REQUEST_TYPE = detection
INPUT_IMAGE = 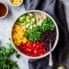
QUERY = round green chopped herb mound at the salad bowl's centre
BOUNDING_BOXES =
[26,27,41,42]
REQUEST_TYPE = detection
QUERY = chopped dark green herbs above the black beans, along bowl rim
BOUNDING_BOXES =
[41,17,55,32]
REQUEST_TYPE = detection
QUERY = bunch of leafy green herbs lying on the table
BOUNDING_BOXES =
[0,44,19,69]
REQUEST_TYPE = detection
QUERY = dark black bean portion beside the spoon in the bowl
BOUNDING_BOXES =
[41,30,56,50]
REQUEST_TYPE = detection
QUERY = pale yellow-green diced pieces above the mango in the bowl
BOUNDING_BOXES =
[17,13,36,26]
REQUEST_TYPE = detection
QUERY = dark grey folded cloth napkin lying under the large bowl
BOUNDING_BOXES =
[24,0,69,69]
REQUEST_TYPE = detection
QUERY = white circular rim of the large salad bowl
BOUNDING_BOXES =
[11,10,59,59]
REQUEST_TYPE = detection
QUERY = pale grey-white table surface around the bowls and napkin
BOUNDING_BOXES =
[0,0,69,69]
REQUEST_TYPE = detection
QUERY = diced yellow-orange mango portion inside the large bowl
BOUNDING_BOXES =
[12,25,27,46]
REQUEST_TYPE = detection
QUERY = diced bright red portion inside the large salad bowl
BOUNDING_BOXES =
[19,41,46,57]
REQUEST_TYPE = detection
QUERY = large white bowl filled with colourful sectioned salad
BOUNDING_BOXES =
[11,10,59,59]
